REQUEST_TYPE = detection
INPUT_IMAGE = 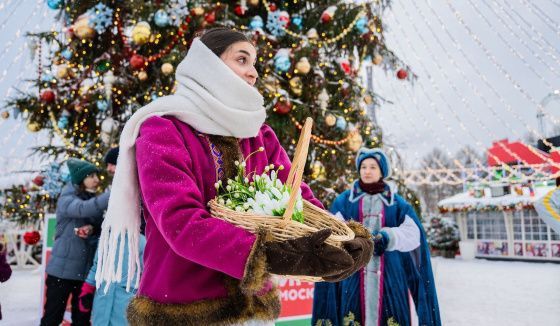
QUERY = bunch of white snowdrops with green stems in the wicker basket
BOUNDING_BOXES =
[215,147,304,223]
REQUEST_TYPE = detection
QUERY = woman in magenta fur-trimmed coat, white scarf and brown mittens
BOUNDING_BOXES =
[96,28,372,325]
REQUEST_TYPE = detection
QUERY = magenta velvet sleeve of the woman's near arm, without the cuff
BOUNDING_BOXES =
[136,117,257,280]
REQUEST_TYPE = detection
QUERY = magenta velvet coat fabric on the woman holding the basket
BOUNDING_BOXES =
[136,117,323,303]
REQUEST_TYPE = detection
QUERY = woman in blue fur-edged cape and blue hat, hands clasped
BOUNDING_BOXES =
[312,148,441,326]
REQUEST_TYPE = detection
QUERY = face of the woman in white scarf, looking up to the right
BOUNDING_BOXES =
[220,42,259,86]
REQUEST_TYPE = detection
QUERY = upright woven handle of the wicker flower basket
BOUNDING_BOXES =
[282,118,313,221]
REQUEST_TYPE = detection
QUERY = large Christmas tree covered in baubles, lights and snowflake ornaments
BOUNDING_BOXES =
[2,0,412,224]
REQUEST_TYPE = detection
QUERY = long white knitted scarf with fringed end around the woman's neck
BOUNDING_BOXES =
[95,39,266,291]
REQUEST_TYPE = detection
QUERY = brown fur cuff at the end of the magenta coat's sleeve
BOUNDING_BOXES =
[239,229,272,294]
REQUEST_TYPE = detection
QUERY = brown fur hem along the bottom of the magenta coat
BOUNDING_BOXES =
[127,277,280,326]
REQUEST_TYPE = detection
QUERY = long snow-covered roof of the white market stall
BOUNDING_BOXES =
[438,186,555,210]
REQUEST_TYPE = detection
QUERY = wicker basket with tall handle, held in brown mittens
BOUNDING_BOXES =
[208,118,354,282]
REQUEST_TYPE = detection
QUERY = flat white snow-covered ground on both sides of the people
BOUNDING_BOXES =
[0,258,560,326]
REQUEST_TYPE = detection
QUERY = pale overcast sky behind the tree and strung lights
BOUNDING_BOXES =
[0,0,560,175]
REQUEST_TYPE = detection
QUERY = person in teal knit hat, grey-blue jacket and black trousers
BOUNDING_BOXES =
[41,159,110,325]
